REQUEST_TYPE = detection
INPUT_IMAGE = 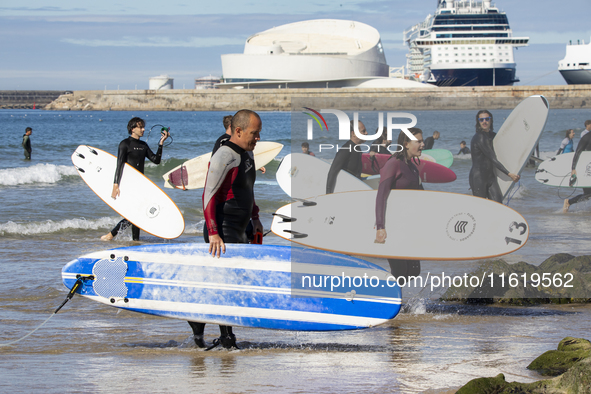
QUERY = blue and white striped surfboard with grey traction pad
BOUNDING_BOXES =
[62,244,401,331]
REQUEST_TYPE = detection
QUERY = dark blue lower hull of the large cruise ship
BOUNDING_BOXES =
[429,67,519,86]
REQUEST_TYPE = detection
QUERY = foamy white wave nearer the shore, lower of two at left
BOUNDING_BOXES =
[0,217,121,235]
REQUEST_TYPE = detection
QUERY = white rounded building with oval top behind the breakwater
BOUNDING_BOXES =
[217,19,428,88]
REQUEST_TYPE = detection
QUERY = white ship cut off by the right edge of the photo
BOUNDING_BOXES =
[558,41,591,85]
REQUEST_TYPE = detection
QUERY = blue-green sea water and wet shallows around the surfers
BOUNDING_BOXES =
[0,106,591,393]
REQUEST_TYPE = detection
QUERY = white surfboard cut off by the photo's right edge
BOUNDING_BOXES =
[536,152,591,188]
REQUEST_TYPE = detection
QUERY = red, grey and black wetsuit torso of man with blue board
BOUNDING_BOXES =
[203,141,259,243]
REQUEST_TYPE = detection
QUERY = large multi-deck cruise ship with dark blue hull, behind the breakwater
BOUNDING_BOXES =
[404,0,529,86]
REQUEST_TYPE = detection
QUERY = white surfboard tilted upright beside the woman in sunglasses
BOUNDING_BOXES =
[493,96,549,198]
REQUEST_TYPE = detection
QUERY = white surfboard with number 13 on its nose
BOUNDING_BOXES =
[271,190,529,260]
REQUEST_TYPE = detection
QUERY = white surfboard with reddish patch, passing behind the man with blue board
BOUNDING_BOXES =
[162,141,283,190]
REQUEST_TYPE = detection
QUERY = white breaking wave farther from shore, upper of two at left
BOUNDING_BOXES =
[0,164,78,186]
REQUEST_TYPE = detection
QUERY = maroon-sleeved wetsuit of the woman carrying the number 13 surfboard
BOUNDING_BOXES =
[376,156,424,278]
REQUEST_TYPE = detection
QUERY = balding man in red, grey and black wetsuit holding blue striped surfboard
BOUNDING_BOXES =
[197,109,263,349]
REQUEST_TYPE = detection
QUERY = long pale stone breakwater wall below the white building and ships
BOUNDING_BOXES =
[45,85,591,112]
